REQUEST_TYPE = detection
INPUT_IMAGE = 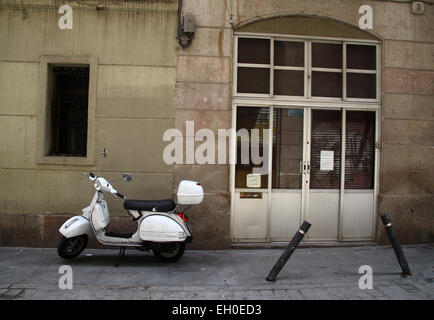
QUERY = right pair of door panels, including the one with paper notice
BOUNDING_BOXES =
[304,109,376,241]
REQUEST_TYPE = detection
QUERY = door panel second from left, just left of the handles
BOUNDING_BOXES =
[269,107,306,241]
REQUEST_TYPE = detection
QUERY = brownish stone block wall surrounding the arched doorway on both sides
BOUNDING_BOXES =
[174,0,434,246]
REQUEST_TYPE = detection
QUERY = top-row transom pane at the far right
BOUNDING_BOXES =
[347,44,377,70]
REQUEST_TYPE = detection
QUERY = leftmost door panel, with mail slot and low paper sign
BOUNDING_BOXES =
[232,106,271,242]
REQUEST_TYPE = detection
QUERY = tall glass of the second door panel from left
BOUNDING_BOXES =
[272,108,304,189]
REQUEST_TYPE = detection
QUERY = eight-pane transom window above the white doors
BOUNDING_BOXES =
[234,35,379,102]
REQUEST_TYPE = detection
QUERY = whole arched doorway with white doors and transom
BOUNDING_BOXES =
[231,16,381,242]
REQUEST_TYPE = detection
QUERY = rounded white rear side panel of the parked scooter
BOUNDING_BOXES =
[139,214,186,242]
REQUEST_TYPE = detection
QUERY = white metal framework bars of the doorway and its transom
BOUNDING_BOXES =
[229,32,382,242]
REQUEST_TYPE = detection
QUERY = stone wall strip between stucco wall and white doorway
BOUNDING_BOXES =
[173,1,232,249]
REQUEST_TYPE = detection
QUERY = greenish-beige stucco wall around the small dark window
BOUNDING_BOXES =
[0,1,177,245]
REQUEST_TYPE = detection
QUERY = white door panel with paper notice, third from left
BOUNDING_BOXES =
[305,110,342,241]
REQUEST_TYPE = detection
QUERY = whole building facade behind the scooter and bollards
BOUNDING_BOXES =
[0,0,434,249]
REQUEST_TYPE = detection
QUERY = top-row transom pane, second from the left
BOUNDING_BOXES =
[274,41,304,67]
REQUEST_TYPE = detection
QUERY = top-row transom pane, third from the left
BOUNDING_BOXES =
[312,42,342,69]
